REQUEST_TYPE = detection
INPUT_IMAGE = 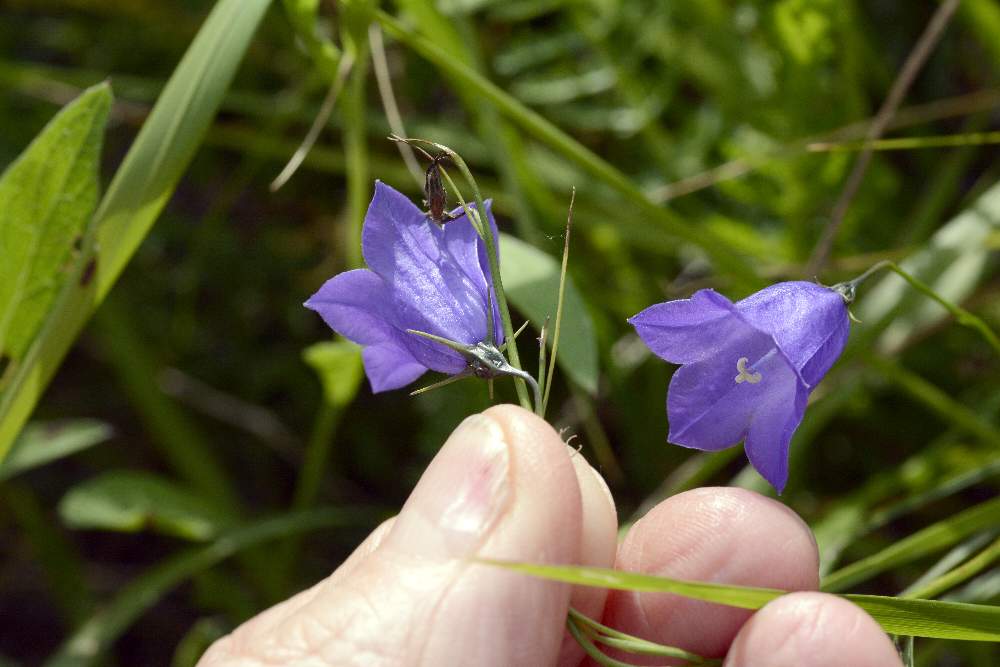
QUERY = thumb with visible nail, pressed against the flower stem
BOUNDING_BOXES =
[202,407,582,665]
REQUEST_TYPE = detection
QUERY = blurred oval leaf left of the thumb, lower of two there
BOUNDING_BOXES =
[59,471,232,540]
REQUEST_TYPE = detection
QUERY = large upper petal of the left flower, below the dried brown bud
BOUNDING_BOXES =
[362,182,496,350]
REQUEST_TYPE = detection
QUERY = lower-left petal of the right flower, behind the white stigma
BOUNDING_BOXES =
[667,326,776,451]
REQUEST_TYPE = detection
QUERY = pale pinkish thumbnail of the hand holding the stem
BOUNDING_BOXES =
[387,415,511,558]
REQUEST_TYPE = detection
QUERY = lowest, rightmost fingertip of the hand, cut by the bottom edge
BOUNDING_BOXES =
[725,593,902,667]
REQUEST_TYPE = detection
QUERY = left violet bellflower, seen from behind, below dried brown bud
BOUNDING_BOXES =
[305,181,503,392]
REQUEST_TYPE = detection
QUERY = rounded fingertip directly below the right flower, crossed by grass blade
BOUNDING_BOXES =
[605,488,819,657]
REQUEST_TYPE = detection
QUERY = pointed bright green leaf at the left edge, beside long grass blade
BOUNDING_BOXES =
[0,83,111,370]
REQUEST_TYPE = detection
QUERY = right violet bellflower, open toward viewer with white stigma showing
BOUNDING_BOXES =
[629,282,850,493]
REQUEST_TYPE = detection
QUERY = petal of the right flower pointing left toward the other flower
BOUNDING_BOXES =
[629,289,750,368]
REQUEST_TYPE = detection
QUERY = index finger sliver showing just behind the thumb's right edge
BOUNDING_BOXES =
[556,448,618,667]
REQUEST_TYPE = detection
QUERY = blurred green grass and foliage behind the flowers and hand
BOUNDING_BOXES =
[0,0,1000,665]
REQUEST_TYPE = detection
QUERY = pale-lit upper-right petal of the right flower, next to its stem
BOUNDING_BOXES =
[736,281,850,386]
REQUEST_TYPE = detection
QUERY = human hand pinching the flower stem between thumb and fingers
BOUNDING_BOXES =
[199,406,901,667]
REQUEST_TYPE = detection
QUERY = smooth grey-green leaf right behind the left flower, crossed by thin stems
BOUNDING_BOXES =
[500,234,598,394]
